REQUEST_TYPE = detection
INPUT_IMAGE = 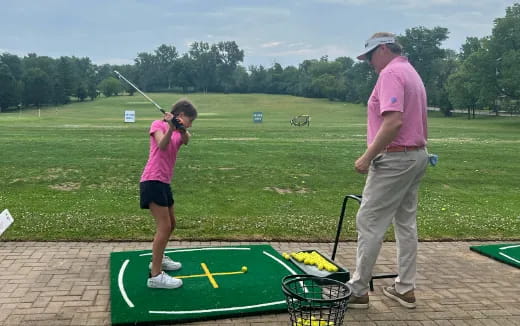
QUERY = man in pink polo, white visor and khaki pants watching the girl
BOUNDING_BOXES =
[348,33,428,308]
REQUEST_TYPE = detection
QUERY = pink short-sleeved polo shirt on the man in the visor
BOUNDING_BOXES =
[367,56,428,146]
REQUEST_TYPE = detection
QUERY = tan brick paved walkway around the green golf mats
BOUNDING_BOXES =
[0,241,520,326]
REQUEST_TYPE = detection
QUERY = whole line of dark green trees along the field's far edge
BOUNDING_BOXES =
[0,3,520,117]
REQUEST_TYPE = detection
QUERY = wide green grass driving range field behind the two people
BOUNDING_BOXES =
[0,94,520,241]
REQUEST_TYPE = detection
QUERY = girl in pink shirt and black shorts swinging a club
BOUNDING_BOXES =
[139,99,197,289]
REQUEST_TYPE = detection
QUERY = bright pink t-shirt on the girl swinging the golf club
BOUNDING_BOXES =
[140,120,182,184]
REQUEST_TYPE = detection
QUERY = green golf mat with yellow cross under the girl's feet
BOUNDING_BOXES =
[110,245,303,325]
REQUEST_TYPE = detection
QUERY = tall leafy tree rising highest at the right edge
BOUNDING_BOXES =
[447,4,520,118]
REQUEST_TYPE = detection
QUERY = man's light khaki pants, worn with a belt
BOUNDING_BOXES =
[348,149,428,296]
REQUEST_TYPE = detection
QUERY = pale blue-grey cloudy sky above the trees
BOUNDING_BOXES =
[0,0,514,67]
